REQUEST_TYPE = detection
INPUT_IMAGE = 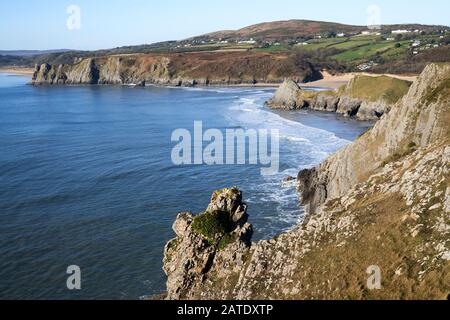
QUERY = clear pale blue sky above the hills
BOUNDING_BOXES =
[0,0,450,50]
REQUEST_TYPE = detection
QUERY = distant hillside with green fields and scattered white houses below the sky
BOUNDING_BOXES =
[0,20,450,74]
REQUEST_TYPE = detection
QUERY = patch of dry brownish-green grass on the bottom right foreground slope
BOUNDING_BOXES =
[286,190,449,300]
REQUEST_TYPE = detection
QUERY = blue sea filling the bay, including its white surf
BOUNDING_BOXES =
[0,74,367,299]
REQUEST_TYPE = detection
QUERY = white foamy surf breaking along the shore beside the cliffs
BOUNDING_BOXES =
[221,91,350,238]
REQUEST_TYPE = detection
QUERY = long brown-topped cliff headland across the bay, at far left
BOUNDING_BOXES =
[32,52,320,86]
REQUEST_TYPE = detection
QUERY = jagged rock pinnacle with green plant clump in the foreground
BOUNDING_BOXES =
[164,188,253,299]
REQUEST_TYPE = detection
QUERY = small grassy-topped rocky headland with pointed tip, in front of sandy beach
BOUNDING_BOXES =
[267,76,410,120]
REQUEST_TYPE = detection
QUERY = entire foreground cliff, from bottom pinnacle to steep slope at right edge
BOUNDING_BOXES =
[165,64,450,299]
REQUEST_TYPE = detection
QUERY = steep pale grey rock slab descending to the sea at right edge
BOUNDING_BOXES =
[298,64,450,213]
